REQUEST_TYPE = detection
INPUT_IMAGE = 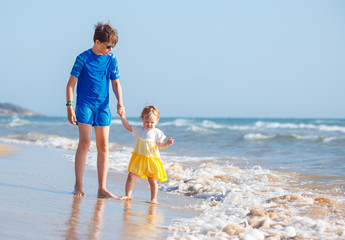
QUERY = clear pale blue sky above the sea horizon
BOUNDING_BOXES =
[0,0,345,118]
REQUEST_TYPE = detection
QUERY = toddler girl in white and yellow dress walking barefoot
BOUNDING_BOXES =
[120,106,175,204]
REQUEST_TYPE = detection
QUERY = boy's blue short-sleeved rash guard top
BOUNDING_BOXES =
[71,49,120,108]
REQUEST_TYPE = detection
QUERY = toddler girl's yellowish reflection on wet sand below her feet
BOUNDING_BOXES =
[121,201,163,239]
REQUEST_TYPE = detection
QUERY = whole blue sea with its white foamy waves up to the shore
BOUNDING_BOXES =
[0,117,345,239]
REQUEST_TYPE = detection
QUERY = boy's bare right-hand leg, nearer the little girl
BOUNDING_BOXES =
[95,126,116,198]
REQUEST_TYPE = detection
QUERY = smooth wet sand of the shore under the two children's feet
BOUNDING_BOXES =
[0,144,200,239]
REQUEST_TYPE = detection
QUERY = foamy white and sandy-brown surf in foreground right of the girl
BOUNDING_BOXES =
[160,163,345,239]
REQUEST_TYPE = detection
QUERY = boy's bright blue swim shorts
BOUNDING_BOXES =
[75,105,111,127]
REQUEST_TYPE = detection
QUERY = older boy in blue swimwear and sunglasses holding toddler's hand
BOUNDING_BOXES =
[66,23,125,198]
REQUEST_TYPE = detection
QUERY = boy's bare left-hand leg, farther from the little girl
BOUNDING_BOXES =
[73,123,92,196]
